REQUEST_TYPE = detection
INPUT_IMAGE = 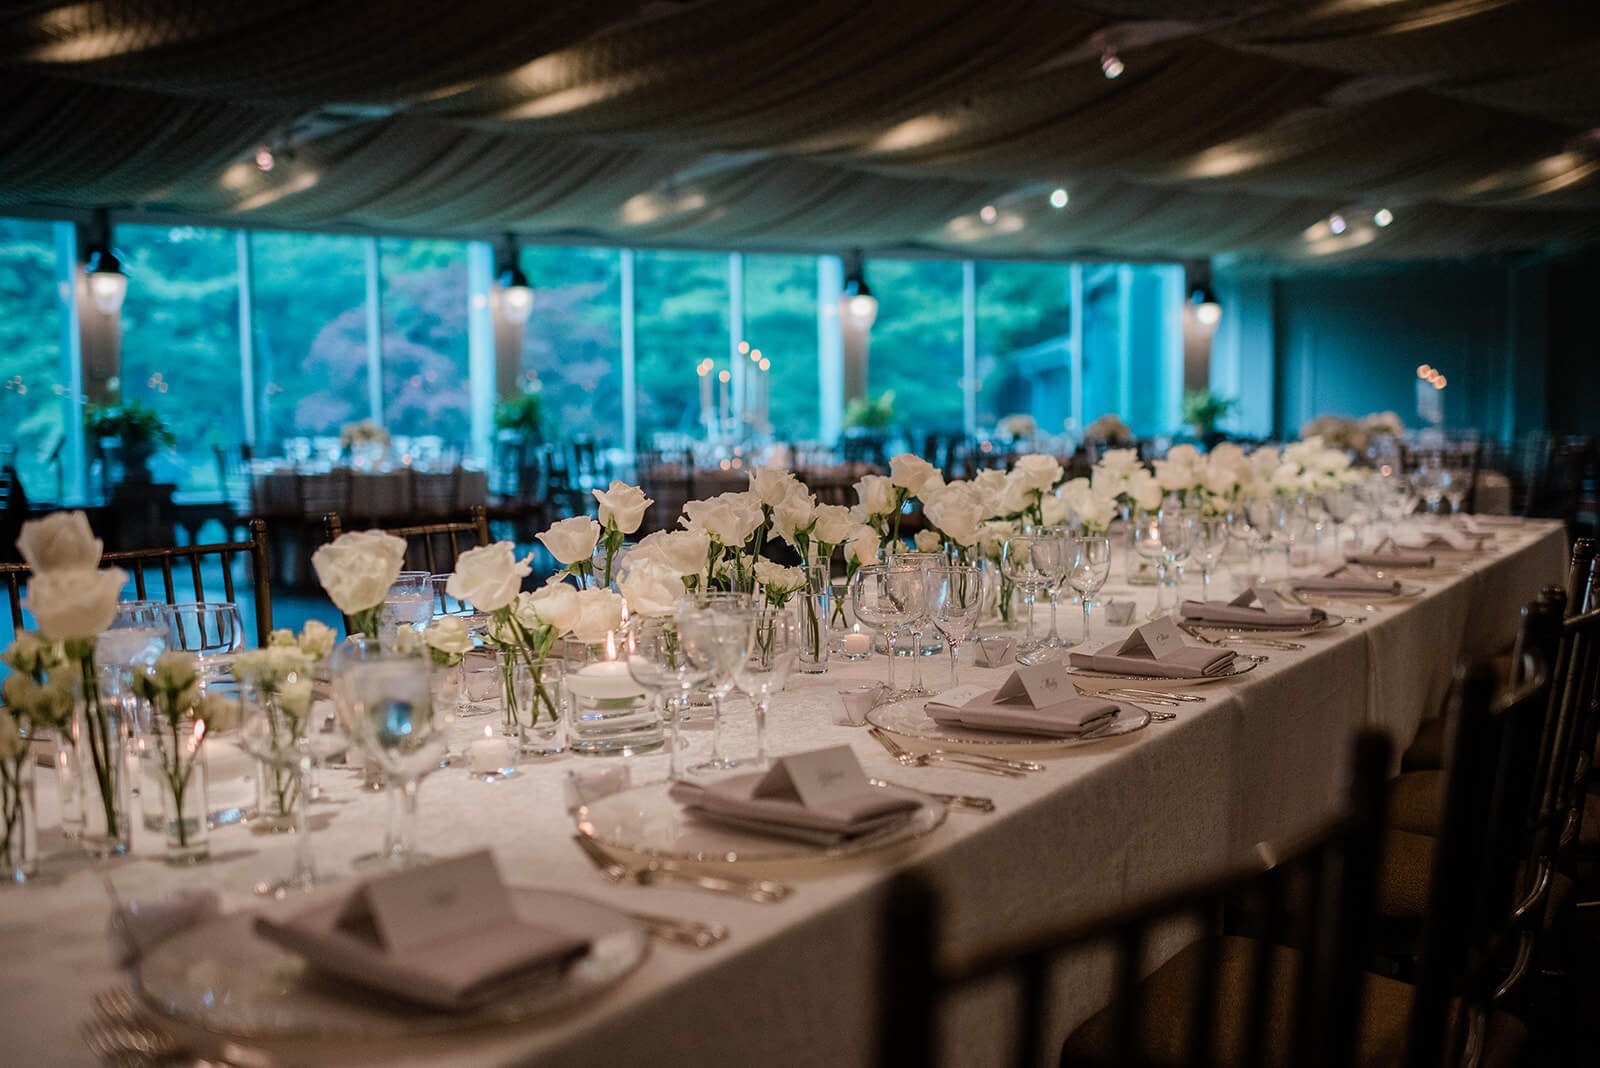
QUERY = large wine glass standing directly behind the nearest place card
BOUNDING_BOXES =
[331,639,448,868]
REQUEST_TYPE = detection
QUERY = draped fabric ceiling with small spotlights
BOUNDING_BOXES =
[0,0,1600,262]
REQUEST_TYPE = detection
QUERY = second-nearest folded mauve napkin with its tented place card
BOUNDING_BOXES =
[669,745,922,847]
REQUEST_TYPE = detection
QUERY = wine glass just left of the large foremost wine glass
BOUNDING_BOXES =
[238,676,350,899]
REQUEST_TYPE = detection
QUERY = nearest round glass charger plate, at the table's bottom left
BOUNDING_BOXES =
[134,887,650,1042]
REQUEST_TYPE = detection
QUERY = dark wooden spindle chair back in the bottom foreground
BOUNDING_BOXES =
[878,732,1390,1068]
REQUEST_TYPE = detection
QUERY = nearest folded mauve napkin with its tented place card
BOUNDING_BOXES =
[256,851,589,1012]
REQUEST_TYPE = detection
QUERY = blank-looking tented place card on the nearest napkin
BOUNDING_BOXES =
[338,849,517,953]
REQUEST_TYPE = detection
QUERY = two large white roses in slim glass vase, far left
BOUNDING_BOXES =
[16,512,130,854]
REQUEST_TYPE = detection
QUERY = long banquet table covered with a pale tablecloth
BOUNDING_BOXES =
[0,521,1566,1066]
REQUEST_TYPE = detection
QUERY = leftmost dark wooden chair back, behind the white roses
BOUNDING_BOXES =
[0,520,272,646]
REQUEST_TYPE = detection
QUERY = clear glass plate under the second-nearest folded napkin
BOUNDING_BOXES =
[576,782,946,865]
